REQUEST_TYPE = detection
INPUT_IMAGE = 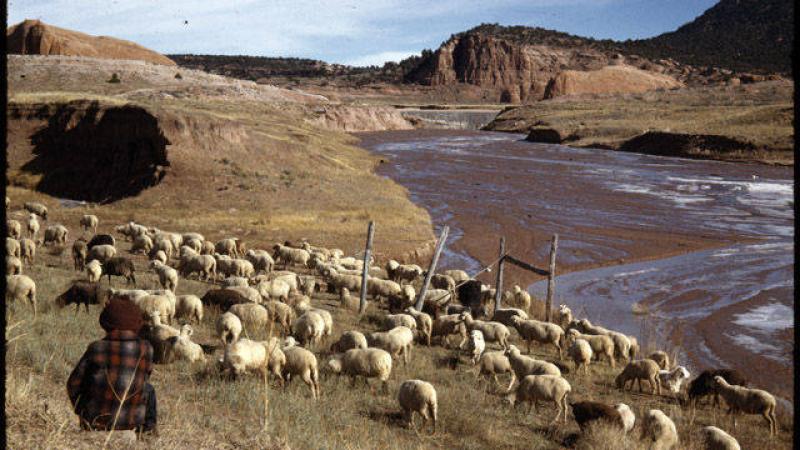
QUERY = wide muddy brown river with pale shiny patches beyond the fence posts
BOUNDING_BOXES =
[358,130,794,404]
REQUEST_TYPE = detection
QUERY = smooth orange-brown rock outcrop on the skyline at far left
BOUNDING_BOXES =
[6,20,175,66]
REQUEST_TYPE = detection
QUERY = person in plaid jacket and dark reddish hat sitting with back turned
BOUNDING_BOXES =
[67,299,157,434]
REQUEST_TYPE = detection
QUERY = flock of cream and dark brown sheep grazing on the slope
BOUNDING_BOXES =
[6,198,777,449]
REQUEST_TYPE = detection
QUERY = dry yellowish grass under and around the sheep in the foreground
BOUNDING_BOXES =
[5,212,793,449]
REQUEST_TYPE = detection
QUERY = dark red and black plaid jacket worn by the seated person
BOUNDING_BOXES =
[67,330,153,430]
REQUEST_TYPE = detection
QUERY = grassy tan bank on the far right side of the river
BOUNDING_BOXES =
[486,81,794,165]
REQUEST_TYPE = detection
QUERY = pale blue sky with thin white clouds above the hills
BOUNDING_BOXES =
[8,0,716,65]
